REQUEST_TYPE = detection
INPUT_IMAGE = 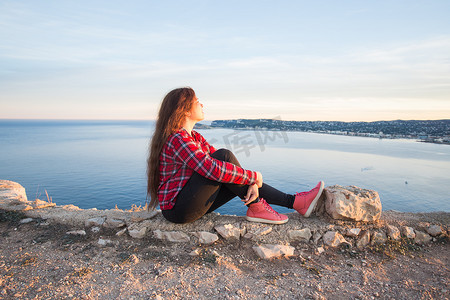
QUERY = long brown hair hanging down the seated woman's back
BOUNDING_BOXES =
[147,87,195,210]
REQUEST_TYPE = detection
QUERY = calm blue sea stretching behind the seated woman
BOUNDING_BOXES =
[0,120,450,215]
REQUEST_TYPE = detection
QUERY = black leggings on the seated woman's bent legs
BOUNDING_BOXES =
[162,149,295,223]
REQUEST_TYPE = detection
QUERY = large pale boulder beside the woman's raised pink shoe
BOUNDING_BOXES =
[325,185,381,222]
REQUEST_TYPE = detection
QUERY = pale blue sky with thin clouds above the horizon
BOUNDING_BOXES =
[0,0,450,121]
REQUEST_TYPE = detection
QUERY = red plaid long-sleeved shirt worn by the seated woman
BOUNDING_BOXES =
[158,129,256,210]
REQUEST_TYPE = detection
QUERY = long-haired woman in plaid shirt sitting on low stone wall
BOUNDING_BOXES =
[147,88,324,224]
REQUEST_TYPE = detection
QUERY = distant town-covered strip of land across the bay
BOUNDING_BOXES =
[197,119,450,145]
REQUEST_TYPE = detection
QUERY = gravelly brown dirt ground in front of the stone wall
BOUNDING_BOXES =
[0,211,450,299]
